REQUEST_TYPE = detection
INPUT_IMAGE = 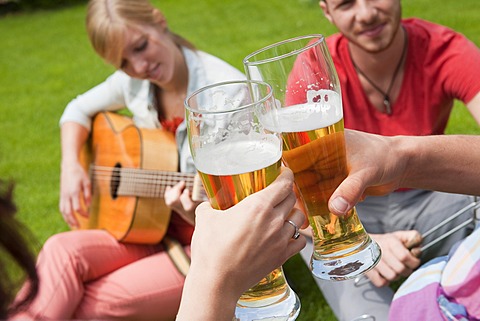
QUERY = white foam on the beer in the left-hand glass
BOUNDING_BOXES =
[194,135,282,175]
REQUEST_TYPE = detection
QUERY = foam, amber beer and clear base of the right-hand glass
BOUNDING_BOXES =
[266,103,380,280]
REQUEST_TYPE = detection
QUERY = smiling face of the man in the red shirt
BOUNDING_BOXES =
[320,0,401,53]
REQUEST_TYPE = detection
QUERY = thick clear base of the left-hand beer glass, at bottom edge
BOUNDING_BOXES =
[234,287,301,321]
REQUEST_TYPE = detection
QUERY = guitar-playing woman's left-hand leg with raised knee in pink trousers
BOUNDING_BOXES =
[13,230,159,320]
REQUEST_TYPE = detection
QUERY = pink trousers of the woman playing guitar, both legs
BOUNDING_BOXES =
[13,230,190,320]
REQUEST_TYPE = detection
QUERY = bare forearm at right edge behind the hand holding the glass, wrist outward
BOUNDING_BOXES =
[398,135,480,195]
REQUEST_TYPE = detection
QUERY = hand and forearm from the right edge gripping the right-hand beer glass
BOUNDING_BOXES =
[329,130,480,215]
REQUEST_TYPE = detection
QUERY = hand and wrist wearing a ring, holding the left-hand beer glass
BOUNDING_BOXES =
[177,169,305,321]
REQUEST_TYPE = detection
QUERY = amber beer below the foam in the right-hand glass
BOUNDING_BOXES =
[282,119,368,256]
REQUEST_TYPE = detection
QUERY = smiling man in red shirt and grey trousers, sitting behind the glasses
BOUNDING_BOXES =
[293,0,480,321]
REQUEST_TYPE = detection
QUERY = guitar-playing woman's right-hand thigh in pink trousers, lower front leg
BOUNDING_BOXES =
[74,247,190,321]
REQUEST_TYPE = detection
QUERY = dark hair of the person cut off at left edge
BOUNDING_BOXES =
[0,180,39,319]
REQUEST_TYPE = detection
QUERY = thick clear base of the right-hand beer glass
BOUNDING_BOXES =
[310,238,381,281]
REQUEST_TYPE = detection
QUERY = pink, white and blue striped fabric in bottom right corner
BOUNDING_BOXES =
[389,228,480,321]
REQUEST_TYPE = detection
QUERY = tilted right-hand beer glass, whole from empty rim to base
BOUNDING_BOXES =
[243,35,381,280]
